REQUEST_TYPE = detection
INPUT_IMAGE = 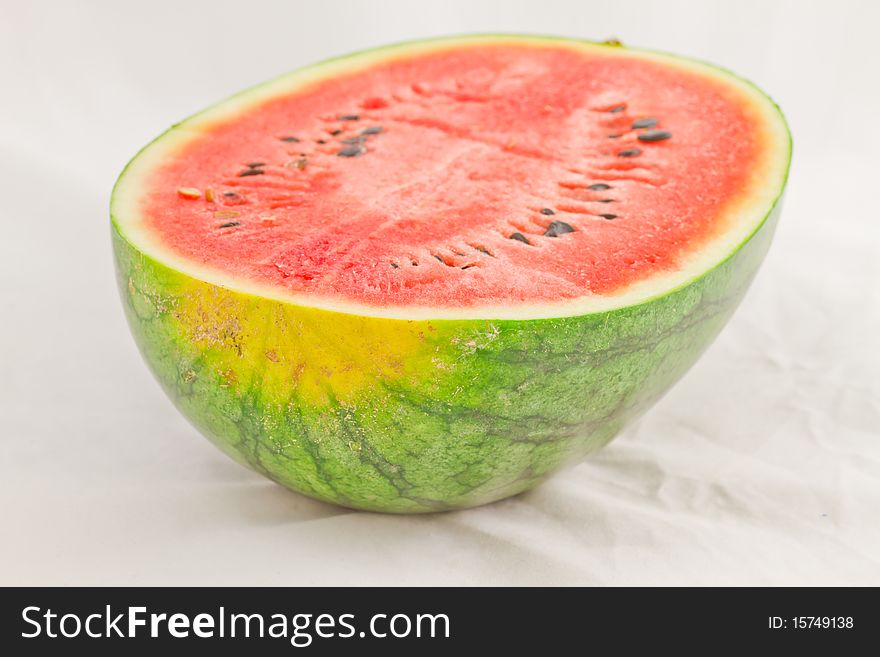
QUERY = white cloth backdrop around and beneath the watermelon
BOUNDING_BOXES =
[0,0,880,585]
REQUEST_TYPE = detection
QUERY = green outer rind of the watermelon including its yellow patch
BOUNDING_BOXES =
[113,203,779,513]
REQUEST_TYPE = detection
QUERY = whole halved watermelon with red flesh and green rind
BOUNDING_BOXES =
[111,36,791,513]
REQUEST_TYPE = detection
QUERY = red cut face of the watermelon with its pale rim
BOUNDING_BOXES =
[112,37,790,319]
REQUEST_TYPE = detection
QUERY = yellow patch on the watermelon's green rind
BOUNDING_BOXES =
[173,279,439,406]
